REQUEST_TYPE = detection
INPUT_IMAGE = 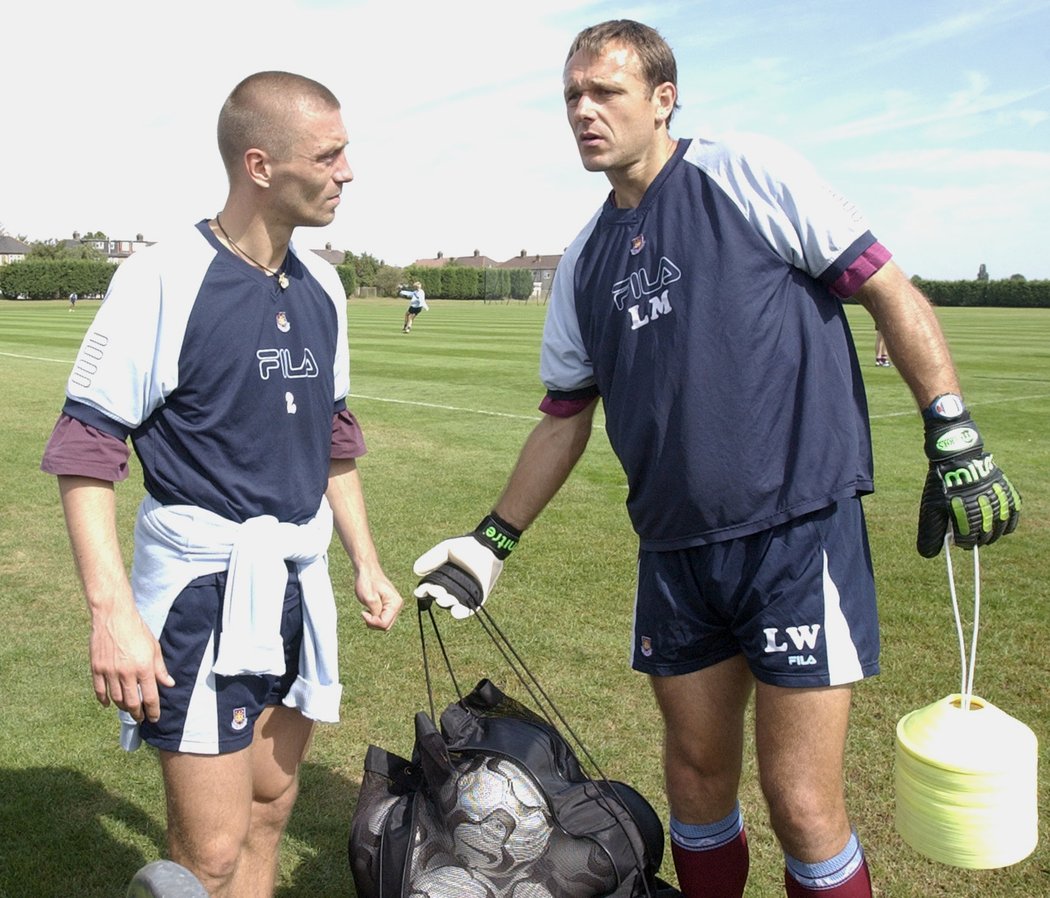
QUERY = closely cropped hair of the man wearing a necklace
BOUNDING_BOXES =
[218,71,339,174]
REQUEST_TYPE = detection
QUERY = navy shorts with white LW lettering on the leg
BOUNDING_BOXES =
[631,499,879,687]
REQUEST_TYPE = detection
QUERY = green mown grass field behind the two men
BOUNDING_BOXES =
[0,300,1050,898]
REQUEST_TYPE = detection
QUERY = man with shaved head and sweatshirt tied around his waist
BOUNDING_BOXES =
[41,71,402,898]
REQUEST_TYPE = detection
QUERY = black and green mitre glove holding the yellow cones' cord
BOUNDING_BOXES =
[916,393,1021,558]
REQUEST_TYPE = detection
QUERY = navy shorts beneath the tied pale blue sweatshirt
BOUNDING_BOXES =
[139,565,302,754]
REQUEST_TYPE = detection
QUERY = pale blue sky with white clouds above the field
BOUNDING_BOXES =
[6,0,1050,278]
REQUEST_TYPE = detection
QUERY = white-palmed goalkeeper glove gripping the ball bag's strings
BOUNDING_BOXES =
[412,515,522,620]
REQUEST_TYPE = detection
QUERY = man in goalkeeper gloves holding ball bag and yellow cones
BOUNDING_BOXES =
[415,20,1021,898]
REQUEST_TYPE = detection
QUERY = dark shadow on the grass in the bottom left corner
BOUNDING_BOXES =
[0,767,164,898]
